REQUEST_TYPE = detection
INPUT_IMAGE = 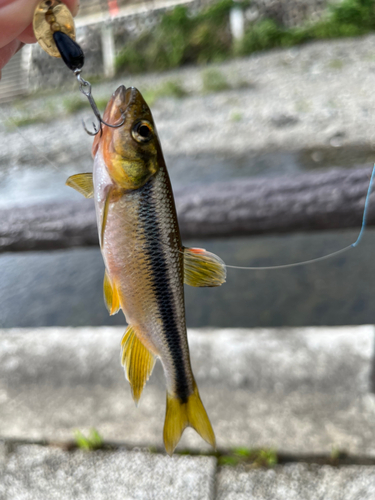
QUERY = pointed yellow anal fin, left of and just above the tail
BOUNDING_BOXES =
[121,325,155,404]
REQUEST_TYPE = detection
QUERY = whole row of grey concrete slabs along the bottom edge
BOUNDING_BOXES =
[0,445,375,500]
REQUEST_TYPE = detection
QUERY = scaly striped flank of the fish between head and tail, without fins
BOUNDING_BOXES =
[99,162,193,400]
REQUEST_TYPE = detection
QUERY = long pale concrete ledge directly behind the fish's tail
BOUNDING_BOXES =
[0,326,375,456]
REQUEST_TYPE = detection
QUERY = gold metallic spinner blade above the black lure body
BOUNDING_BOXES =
[33,0,76,57]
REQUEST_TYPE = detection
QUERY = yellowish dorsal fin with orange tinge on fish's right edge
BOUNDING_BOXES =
[184,248,227,287]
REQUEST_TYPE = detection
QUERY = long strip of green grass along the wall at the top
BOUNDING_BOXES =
[116,0,375,73]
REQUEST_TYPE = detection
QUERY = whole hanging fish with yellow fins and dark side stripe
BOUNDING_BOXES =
[66,85,226,455]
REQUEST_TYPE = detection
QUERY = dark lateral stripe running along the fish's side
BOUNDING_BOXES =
[139,181,191,403]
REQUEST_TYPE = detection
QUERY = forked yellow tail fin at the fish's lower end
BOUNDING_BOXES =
[164,382,216,455]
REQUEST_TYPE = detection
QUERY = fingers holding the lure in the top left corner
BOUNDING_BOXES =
[0,0,79,75]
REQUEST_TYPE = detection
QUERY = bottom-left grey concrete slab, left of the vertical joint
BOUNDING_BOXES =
[0,445,216,500]
